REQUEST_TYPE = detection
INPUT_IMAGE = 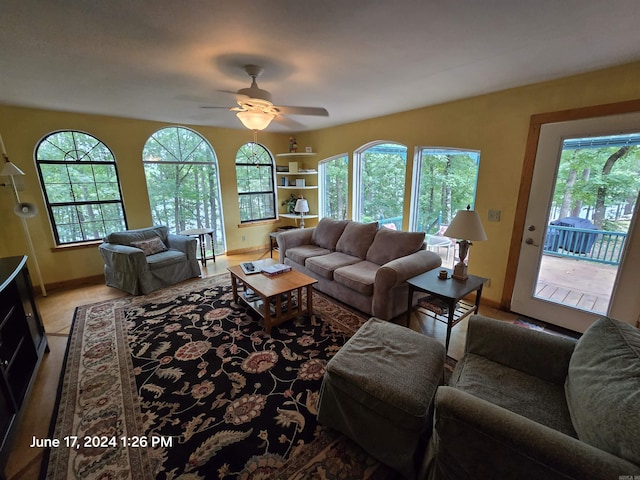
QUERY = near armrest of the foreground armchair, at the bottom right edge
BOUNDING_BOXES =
[428,387,640,480]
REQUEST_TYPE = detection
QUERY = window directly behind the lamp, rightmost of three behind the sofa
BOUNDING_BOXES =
[409,147,480,234]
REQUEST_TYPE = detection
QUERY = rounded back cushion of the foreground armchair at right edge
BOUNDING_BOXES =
[565,317,640,465]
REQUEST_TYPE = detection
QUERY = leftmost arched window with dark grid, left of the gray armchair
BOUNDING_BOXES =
[36,131,127,245]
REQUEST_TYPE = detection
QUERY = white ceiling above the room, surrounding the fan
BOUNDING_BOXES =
[0,0,640,131]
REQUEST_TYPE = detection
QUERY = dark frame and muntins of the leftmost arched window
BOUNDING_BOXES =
[34,130,128,246]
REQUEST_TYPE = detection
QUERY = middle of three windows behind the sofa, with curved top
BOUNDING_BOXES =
[353,143,407,230]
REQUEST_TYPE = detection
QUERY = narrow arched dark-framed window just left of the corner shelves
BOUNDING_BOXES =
[236,142,276,223]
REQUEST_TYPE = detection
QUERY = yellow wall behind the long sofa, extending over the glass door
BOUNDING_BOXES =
[297,63,640,304]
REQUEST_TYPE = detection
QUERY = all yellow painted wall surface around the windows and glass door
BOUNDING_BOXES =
[0,63,640,304]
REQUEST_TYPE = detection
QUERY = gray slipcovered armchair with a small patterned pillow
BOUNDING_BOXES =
[98,226,200,295]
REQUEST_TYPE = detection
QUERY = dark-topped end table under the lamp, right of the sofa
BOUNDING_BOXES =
[407,268,487,352]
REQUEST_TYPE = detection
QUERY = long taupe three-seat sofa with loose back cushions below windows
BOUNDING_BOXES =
[278,218,442,320]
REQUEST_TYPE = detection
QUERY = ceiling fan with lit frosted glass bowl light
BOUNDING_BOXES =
[202,65,329,130]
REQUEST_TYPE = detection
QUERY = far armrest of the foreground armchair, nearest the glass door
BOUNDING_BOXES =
[465,315,576,385]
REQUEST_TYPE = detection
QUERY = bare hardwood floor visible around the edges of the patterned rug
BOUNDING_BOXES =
[5,250,516,480]
